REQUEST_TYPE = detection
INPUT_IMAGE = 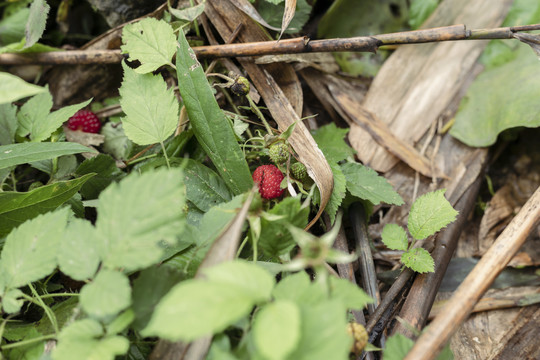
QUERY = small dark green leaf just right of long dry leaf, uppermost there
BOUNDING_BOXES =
[313,123,355,164]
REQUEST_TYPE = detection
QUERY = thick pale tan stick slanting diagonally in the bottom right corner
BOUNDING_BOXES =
[405,187,540,360]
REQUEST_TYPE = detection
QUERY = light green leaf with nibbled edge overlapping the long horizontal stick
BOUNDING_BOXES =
[121,17,177,74]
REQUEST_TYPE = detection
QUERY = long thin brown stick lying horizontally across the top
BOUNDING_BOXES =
[0,24,540,65]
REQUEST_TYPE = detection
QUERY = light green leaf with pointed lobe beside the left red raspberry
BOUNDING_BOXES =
[17,91,91,142]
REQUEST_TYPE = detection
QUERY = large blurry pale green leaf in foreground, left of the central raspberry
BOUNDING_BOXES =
[96,168,185,272]
